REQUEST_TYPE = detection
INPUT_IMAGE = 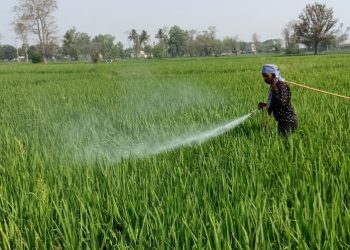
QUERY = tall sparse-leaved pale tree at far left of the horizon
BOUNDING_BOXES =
[14,0,57,63]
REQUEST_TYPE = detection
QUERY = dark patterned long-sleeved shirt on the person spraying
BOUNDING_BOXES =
[267,81,297,123]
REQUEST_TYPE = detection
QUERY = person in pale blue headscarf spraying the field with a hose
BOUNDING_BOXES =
[258,64,298,136]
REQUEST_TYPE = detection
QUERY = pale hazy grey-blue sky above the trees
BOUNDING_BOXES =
[0,0,350,45]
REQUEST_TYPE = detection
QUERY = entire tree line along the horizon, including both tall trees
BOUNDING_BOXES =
[0,0,347,63]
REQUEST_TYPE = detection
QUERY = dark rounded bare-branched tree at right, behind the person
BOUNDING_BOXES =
[295,3,337,55]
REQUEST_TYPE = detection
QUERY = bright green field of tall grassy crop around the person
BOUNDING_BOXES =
[0,55,350,249]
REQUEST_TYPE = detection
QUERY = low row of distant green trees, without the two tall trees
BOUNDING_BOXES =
[0,25,282,62]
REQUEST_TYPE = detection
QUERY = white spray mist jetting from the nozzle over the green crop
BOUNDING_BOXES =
[61,83,254,163]
